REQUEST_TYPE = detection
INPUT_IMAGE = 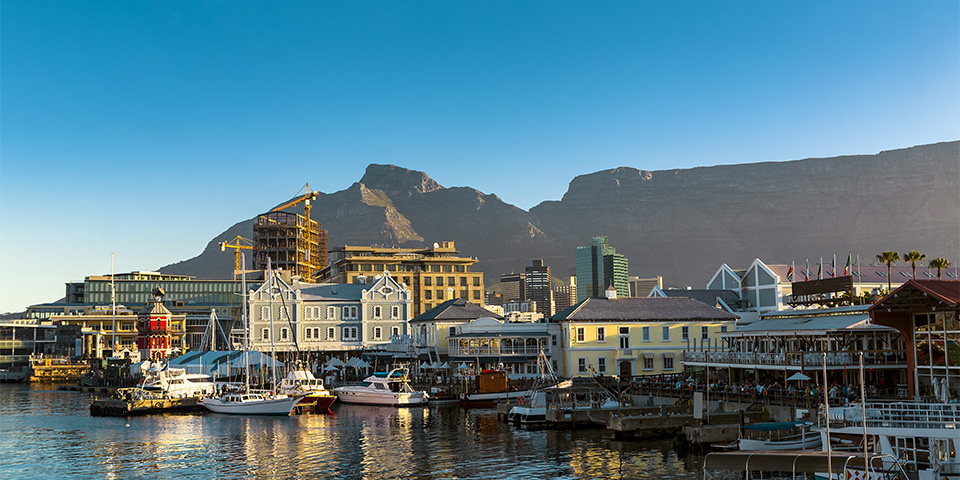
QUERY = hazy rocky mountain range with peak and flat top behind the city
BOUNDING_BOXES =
[161,142,960,287]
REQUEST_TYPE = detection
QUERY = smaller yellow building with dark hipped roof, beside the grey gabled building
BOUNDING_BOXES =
[410,298,503,357]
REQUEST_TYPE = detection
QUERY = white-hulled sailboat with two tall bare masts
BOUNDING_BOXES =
[200,254,306,415]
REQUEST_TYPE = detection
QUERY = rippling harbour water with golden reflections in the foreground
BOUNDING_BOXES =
[0,385,699,479]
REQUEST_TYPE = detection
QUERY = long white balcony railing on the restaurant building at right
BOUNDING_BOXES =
[683,350,907,367]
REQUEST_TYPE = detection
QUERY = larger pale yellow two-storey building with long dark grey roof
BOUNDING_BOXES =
[552,288,737,377]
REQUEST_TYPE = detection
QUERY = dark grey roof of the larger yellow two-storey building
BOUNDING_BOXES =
[553,297,738,322]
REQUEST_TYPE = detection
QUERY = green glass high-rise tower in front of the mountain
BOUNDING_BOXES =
[576,236,630,302]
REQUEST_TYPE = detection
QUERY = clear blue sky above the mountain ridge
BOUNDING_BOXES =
[0,0,960,312]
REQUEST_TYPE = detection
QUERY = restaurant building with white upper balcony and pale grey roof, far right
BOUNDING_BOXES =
[683,305,907,396]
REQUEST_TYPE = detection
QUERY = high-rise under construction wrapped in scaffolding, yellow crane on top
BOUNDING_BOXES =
[253,185,327,279]
